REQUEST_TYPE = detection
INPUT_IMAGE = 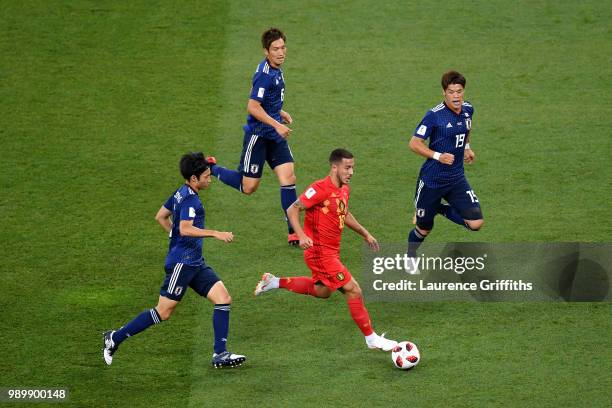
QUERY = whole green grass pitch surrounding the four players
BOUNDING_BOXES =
[0,0,612,407]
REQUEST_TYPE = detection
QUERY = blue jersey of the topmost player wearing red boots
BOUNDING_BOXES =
[245,58,285,140]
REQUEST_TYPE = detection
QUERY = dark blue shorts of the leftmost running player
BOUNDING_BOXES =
[159,263,221,301]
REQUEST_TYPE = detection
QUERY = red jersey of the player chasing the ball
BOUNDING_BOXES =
[300,176,350,256]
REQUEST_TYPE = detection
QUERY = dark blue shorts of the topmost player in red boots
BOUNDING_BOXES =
[238,129,293,178]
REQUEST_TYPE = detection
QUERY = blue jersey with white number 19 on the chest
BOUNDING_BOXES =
[414,102,474,188]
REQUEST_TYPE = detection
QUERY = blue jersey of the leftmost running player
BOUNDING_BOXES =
[164,184,205,266]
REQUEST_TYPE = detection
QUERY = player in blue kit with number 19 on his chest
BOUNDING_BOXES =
[407,71,483,273]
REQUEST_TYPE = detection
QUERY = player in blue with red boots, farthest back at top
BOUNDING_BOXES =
[209,28,299,245]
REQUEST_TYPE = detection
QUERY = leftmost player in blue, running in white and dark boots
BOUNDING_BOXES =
[103,153,246,368]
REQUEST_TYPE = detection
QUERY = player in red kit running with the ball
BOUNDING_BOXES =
[255,149,397,351]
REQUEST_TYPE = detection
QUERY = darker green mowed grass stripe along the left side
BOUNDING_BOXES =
[0,2,230,406]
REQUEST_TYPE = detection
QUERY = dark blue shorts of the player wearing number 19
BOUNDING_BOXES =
[414,177,482,225]
